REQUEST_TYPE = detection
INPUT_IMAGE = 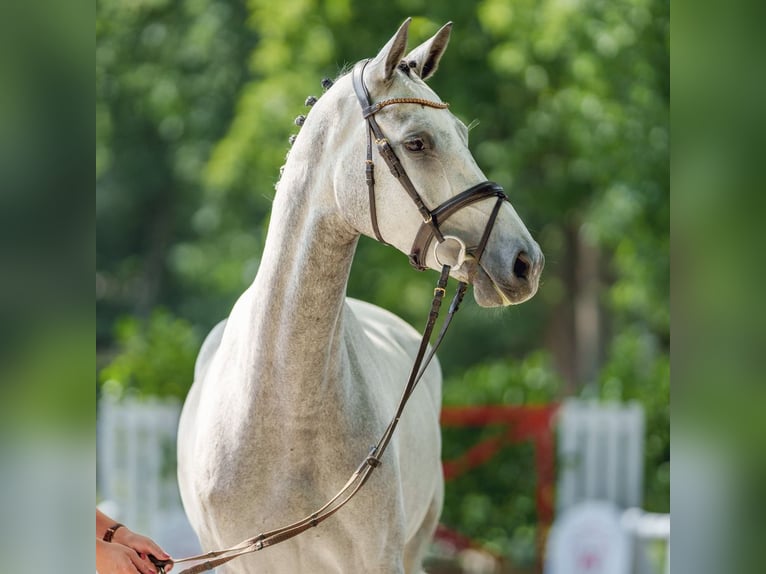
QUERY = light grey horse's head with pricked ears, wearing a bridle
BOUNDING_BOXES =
[322,19,544,307]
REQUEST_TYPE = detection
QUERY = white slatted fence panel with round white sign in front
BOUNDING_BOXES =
[546,400,670,574]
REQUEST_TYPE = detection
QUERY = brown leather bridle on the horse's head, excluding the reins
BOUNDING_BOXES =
[352,60,508,271]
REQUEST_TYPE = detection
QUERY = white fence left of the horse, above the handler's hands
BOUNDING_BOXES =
[97,398,199,556]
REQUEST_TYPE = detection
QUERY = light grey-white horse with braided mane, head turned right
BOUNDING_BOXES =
[178,20,543,574]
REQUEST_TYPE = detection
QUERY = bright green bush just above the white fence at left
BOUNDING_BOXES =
[101,309,200,399]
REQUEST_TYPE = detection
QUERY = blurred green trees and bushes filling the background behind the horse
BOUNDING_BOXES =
[96,0,670,572]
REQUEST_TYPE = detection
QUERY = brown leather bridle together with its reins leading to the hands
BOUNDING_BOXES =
[160,60,507,574]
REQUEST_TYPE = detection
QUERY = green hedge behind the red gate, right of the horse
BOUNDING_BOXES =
[442,351,564,567]
